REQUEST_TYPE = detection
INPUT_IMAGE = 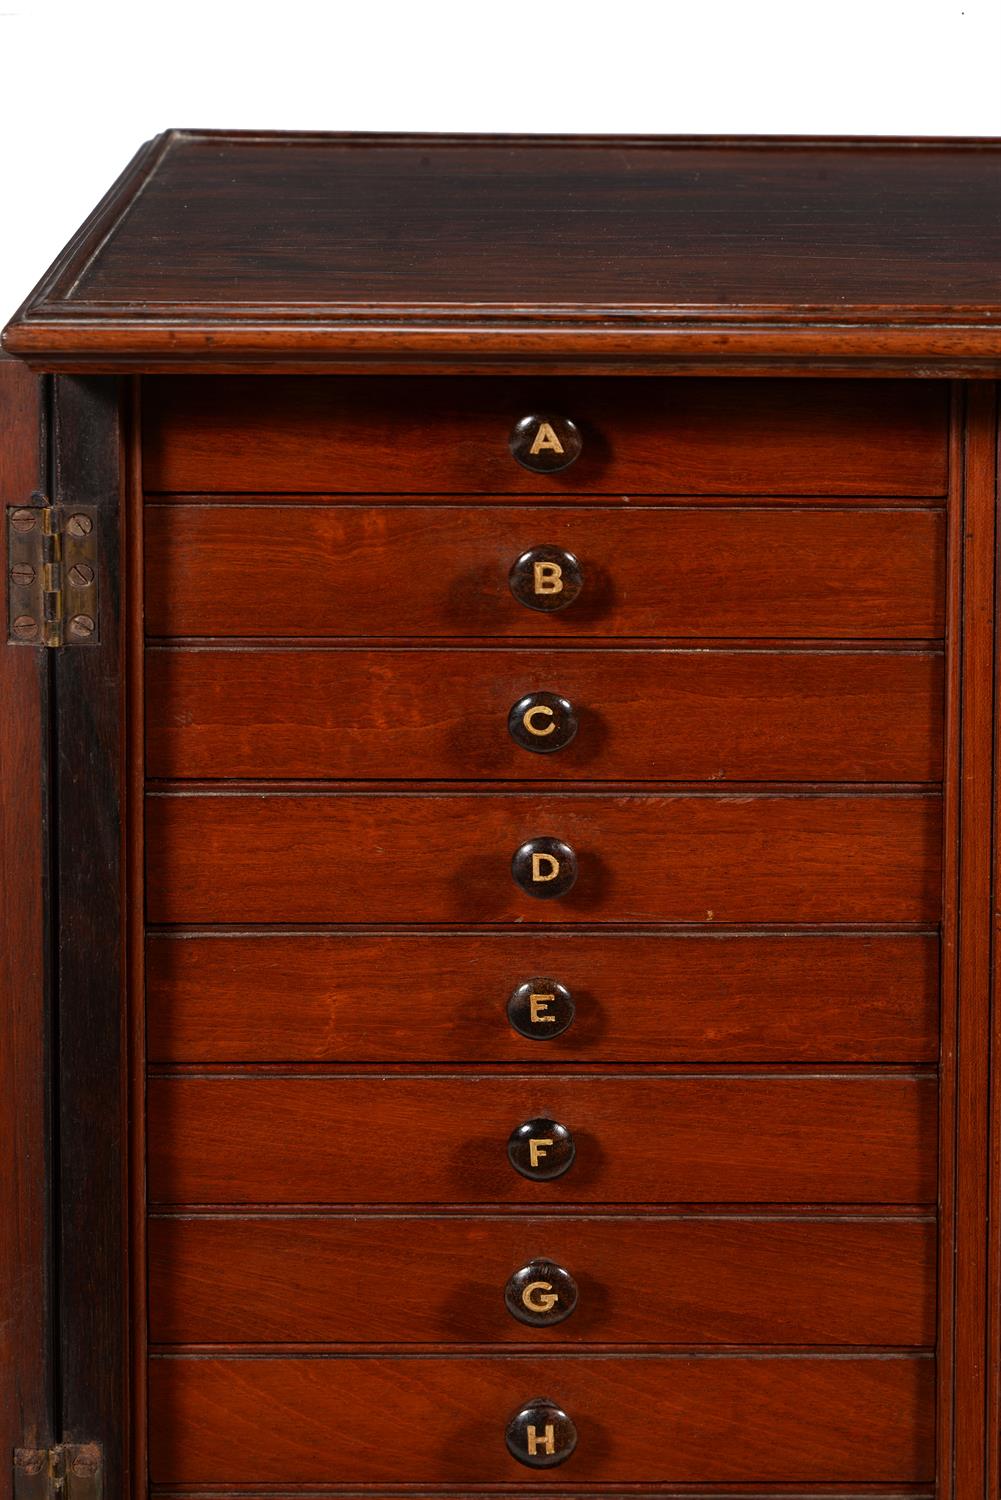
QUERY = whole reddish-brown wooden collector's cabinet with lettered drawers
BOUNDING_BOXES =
[0,132,1001,1500]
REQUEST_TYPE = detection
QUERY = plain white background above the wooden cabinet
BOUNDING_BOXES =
[0,0,1001,323]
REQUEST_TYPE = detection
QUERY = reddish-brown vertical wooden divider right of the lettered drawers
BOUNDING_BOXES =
[938,386,998,1500]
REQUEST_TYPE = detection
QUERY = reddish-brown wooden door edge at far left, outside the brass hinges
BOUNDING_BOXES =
[0,359,56,1500]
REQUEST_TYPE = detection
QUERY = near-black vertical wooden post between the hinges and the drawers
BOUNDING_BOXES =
[53,378,129,1496]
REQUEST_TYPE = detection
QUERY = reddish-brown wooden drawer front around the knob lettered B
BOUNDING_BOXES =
[146,504,945,641]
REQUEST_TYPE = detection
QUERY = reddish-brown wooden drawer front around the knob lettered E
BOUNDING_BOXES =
[146,932,938,1068]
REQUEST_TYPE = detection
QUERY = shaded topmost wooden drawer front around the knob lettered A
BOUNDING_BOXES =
[143,377,947,497]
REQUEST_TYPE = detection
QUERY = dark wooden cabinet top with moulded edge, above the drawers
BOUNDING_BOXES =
[5,131,1001,375]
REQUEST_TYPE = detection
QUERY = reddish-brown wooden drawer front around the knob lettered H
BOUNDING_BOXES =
[150,1353,933,1494]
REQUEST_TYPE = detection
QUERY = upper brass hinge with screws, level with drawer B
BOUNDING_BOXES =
[8,495,98,647]
